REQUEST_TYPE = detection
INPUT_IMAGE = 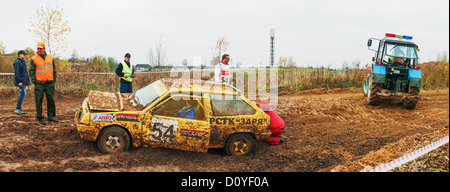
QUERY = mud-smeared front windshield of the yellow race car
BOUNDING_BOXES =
[131,81,168,107]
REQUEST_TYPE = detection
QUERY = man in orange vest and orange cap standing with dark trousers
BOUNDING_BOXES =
[29,42,59,125]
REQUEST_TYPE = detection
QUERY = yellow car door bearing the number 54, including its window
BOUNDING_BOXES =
[142,95,210,152]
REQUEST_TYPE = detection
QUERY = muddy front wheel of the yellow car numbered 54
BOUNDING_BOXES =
[97,126,131,154]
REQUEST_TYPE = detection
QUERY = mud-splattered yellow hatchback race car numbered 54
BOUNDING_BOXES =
[75,79,271,156]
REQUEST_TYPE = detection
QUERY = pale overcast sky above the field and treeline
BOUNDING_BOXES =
[0,0,449,68]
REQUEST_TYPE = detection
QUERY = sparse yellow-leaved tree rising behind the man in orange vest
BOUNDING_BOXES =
[28,5,71,57]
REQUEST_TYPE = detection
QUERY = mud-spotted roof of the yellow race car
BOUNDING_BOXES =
[161,78,241,95]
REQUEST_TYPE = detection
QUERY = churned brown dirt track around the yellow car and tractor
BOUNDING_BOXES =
[0,90,449,172]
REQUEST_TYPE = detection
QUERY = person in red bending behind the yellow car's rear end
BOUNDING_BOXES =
[256,103,285,145]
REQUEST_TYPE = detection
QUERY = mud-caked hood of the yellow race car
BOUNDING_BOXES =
[88,91,136,112]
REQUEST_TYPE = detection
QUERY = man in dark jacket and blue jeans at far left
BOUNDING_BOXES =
[13,50,30,114]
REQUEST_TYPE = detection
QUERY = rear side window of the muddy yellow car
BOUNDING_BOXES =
[210,94,256,116]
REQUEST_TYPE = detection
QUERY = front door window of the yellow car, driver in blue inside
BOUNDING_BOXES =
[153,96,205,120]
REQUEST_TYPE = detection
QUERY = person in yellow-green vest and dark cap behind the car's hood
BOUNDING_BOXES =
[116,53,135,93]
